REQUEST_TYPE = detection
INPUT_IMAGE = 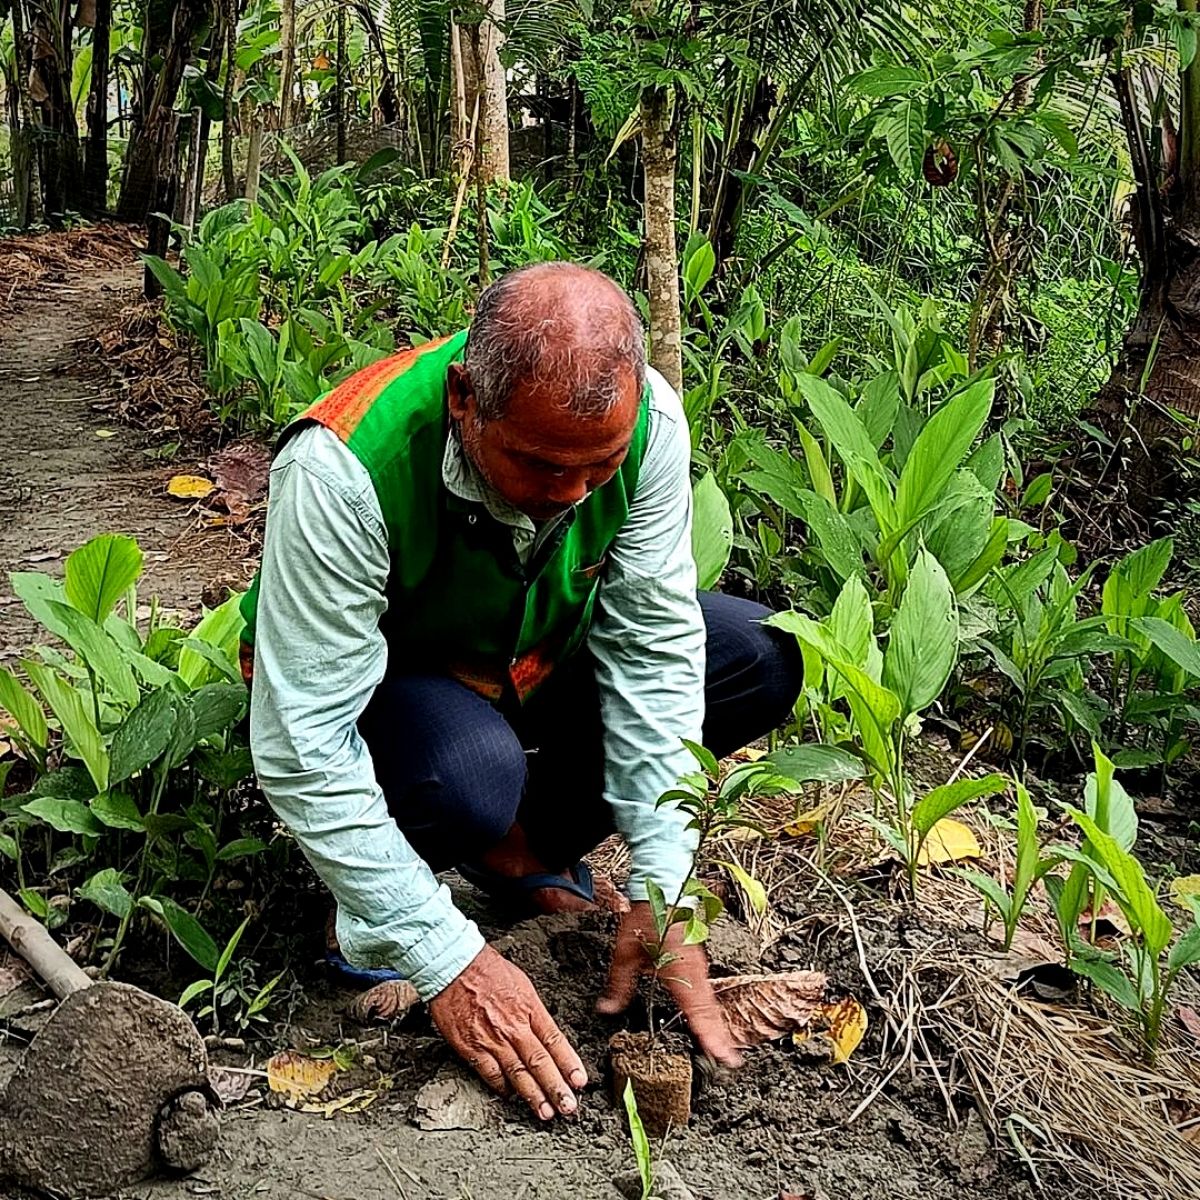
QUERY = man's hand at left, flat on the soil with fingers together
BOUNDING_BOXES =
[430,946,588,1121]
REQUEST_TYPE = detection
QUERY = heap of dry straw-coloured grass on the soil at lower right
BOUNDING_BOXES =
[712,748,1200,1200]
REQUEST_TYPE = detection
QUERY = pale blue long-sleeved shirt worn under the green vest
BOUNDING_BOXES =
[251,371,704,998]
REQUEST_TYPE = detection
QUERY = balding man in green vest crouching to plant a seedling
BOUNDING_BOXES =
[244,263,802,1120]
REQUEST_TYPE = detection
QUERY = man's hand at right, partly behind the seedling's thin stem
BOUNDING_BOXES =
[596,900,742,1067]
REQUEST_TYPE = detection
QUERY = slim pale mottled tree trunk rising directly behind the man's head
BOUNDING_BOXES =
[641,88,683,392]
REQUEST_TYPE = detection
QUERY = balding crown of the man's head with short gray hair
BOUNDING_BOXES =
[463,263,646,421]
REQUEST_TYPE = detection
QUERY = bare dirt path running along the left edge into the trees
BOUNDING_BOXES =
[0,264,240,659]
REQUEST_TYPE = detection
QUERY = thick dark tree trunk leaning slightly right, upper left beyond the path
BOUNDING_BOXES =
[116,0,212,222]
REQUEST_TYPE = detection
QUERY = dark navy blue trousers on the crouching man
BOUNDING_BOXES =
[359,592,804,871]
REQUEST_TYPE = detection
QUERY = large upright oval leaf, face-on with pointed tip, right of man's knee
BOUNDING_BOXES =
[883,550,959,715]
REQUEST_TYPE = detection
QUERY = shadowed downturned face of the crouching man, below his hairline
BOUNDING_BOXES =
[446,364,641,521]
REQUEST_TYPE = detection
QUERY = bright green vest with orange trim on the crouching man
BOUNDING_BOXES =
[242,331,649,702]
